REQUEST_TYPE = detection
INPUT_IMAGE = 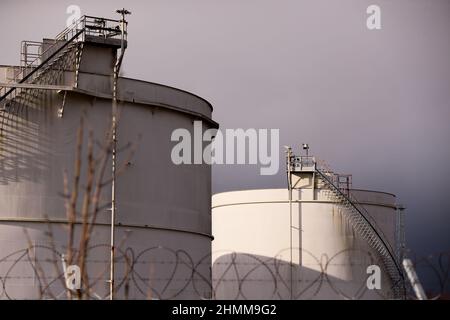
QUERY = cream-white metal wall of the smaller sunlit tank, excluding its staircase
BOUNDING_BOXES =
[212,189,396,299]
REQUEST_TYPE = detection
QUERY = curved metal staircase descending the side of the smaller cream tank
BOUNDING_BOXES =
[288,155,406,299]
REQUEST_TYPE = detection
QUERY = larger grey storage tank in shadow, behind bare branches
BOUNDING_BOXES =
[0,16,218,299]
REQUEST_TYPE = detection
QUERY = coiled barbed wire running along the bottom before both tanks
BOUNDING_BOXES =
[0,244,450,300]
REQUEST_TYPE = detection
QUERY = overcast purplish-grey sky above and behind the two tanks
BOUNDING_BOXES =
[0,0,450,282]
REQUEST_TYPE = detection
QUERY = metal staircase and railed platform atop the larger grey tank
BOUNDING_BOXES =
[0,16,126,137]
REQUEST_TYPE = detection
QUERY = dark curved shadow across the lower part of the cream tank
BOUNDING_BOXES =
[212,250,387,300]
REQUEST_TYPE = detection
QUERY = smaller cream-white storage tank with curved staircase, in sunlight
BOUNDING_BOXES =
[212,156,404,299]
